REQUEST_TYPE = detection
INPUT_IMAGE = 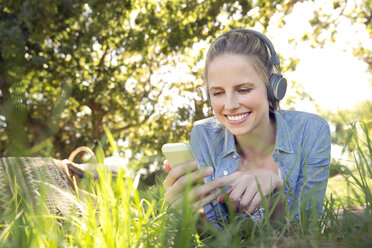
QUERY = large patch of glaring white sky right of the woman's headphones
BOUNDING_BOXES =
[268,1,372,112]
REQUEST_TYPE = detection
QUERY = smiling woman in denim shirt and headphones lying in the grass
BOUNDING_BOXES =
[164,29,331,225]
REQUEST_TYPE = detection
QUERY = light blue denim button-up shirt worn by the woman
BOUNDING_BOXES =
[190,111,331,222]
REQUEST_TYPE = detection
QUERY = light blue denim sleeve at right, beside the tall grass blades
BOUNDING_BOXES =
[296,120,331,217]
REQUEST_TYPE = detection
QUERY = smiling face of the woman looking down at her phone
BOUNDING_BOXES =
[207,54,270,136]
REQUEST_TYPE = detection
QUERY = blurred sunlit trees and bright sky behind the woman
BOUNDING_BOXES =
[0,0,372,184]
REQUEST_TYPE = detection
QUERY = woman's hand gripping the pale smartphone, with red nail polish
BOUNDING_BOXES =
[163,161,221,208]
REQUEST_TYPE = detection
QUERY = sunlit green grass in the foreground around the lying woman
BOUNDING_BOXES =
[0,122,372,247]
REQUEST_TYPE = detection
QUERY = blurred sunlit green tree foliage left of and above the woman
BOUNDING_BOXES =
[0,0,320,161]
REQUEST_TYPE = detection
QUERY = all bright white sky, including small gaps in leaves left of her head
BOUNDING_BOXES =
[155,0,372,113]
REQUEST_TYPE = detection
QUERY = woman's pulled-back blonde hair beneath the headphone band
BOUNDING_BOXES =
[204,31,278,110]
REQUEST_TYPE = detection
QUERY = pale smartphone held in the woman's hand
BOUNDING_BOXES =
[161,143,195,168]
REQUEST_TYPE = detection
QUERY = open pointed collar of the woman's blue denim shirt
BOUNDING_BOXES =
[223,110,293,157]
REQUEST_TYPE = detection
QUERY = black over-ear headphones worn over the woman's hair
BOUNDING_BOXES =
[207,28,287,102]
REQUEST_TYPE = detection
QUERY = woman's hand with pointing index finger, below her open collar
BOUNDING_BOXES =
[215,169,283,214]
